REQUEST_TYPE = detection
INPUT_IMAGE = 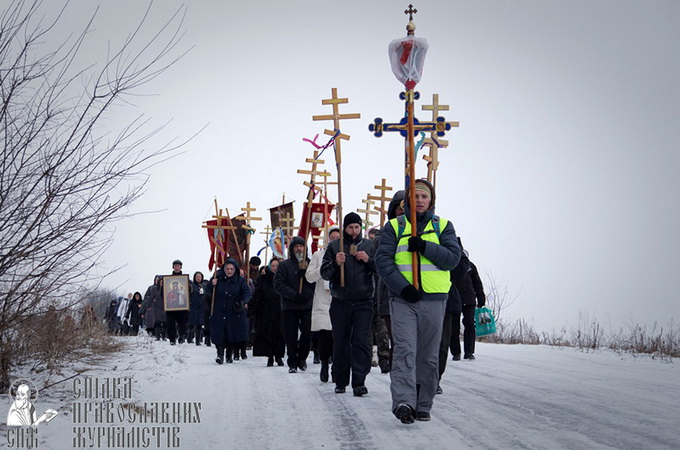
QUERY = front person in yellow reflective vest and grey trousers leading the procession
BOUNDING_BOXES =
[375,180,461,423]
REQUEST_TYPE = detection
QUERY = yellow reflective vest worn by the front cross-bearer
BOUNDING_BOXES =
[390,218,451,294]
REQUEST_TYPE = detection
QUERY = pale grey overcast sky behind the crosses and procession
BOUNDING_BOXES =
[31,0,680,330]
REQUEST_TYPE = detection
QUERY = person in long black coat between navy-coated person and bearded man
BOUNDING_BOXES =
[248,258,286,367]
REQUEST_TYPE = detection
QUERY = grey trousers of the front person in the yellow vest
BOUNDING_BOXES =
[390,297,446,412]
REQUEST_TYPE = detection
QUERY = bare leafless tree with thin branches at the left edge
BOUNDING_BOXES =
[0,0,185,390]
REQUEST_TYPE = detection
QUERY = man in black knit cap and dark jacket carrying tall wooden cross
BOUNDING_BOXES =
[321,212,375,397]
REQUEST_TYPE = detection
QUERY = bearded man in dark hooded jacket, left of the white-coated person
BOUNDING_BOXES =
[274,236,315,373]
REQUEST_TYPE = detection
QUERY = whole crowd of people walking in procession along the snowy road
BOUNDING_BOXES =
[102,180,486,424]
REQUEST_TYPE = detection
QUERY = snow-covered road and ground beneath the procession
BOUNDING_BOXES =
[6,336,680,449]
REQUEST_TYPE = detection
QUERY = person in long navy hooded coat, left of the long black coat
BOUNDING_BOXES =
[210,258,250,364]
